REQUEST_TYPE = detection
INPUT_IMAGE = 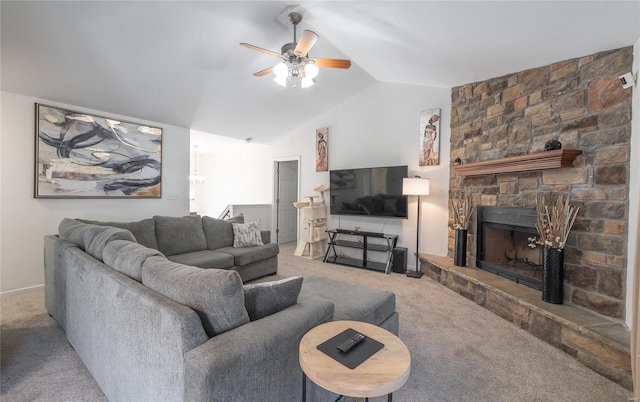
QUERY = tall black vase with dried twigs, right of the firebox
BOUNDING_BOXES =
[529,194,580,304]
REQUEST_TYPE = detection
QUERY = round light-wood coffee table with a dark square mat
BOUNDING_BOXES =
[300,321,411,401]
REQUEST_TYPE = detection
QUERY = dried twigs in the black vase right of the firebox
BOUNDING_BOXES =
[534,194,580,250]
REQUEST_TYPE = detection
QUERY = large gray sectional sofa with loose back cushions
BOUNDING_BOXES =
[44,218,398,402]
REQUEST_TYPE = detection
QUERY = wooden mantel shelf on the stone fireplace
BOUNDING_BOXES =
[453,149,582,176]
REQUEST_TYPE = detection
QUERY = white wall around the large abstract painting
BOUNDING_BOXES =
[0,92,189,291]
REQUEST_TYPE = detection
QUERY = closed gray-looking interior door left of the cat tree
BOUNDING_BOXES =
[276,161,298,244]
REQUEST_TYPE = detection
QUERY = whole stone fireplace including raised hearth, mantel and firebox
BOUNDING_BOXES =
[428,47,633,389]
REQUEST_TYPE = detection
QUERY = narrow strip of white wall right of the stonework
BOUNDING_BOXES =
[625,39,640,327]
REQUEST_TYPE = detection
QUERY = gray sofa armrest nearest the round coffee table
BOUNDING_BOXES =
[184,300,333,401]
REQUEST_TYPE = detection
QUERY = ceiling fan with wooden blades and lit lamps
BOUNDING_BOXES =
[240,12,351,88]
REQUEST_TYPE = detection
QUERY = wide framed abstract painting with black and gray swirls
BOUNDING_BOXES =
[34,103,162,198]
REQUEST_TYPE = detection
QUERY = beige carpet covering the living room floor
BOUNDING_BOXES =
[0,245,632,402]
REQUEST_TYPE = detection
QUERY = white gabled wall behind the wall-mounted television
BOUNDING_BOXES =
[273,82,451,268]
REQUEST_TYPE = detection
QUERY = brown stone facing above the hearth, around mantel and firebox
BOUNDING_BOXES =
[449,47,633,318]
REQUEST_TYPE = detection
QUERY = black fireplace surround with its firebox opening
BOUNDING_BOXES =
[476,206,542,290]
